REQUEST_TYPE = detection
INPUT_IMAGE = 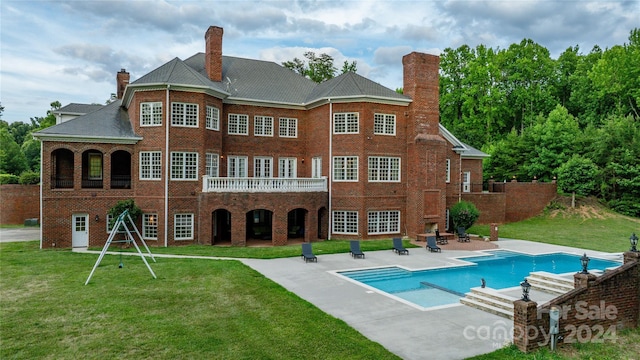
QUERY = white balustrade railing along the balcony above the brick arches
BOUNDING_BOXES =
[202,176,327,192]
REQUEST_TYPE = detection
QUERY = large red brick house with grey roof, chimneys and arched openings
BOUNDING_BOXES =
[35,26,486,248]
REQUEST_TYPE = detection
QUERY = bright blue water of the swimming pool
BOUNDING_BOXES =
[339,250,621,307]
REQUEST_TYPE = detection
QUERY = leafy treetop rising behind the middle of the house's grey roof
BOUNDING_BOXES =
[282,51,358,83]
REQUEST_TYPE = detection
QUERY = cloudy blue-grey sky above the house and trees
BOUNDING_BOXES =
[0,0,640,122]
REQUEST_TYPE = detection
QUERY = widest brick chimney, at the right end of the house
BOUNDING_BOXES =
[402,52,440,137]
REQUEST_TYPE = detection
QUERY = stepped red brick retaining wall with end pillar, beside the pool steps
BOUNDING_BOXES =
[513,252,640,352]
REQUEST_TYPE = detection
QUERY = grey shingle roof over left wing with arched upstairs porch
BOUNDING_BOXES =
[33,100,141,142]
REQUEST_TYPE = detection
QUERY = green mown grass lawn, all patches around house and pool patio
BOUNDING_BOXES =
[0,207,640,359]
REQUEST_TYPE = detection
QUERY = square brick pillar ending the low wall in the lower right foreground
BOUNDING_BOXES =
[513,300,540,352]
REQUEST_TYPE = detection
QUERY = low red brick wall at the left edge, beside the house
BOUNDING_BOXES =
[0,184,40,225]
